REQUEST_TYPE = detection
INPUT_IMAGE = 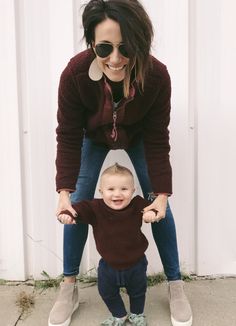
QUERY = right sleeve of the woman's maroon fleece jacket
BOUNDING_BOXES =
[144,66,172,194]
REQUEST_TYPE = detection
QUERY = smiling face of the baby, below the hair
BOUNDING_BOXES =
[100,174,135,210]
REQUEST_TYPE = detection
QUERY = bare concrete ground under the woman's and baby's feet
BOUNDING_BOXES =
[0,278,236,326]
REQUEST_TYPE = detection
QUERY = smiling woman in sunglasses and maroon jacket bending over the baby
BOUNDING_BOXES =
[49,0,192,326]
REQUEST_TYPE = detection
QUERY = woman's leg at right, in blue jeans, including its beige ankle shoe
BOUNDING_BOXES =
[127,142,192,326]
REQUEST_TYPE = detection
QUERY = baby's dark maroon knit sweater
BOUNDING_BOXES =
[62,196,150,270]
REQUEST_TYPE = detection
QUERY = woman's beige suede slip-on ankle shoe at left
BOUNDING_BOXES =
[48,282,79,326]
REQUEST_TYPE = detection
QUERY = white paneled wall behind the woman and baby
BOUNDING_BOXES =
[0,0,236,280]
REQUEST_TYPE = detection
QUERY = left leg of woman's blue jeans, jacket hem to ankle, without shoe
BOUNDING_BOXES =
[63,138,108,276]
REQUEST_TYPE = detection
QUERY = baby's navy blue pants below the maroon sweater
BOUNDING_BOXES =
[98,256,147,318]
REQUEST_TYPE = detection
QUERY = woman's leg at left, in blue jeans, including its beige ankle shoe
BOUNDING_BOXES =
[48,138,108,326]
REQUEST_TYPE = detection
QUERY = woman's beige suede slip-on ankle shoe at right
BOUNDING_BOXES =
[169,280,193,326]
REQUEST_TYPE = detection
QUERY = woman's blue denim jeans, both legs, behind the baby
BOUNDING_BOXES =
[63,138,181,281]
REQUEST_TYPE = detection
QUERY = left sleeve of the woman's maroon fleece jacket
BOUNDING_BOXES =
[56,63,84,191]
